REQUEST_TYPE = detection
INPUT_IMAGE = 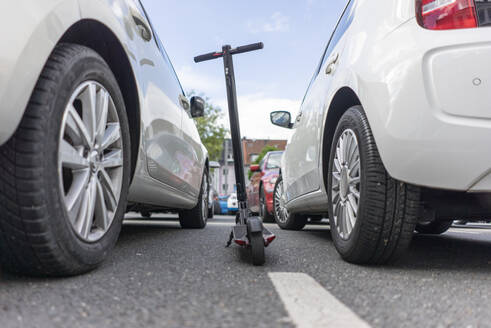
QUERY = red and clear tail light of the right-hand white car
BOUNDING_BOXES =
[416,0,478,30]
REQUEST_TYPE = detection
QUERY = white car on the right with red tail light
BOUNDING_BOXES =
[271,0,491,263]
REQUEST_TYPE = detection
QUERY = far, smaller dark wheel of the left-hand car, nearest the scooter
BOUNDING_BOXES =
[179,171,210,229]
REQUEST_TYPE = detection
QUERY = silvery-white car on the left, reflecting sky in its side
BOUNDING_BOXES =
[0,0,209,275]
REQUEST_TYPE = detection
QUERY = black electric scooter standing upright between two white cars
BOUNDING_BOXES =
[194,42,276,265]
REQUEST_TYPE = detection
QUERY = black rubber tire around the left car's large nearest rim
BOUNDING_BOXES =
[0,43,130,276]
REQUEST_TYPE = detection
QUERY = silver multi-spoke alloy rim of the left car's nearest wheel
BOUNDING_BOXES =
[58,81,123,242]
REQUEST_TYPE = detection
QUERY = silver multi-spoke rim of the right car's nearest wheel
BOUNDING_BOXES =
[331,129,361,240]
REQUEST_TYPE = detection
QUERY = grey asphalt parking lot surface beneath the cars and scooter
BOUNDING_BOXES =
[0,217,491,328]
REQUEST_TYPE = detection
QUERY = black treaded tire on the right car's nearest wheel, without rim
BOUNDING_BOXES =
[328,106,420,264]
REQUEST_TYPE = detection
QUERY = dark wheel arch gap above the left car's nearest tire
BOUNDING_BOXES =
[59,19,141,183]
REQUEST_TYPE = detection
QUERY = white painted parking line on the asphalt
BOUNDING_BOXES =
[268,272,370,328]
